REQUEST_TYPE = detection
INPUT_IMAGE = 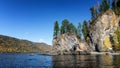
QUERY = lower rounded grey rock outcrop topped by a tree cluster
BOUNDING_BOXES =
[53,33,92,54]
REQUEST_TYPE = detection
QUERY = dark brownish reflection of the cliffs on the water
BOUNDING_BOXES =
[52,55,120,68]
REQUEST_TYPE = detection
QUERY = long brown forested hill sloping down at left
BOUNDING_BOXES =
[0,35,51,53]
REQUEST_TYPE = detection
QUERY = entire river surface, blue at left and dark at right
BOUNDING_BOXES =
[0,53,120,68]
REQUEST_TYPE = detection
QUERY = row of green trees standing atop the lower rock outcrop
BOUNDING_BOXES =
[53,19,81,39]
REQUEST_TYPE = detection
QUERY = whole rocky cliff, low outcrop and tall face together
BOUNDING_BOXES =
[53,10,120,54]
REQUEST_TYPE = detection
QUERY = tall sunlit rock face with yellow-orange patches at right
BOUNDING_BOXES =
[90,10,119,51]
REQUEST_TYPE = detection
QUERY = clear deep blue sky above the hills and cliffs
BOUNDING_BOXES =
[0,0,101,44]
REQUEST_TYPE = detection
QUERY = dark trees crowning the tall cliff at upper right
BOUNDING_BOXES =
[90,0,120,23]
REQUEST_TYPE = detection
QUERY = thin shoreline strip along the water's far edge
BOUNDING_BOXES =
[0,51,120,56]
